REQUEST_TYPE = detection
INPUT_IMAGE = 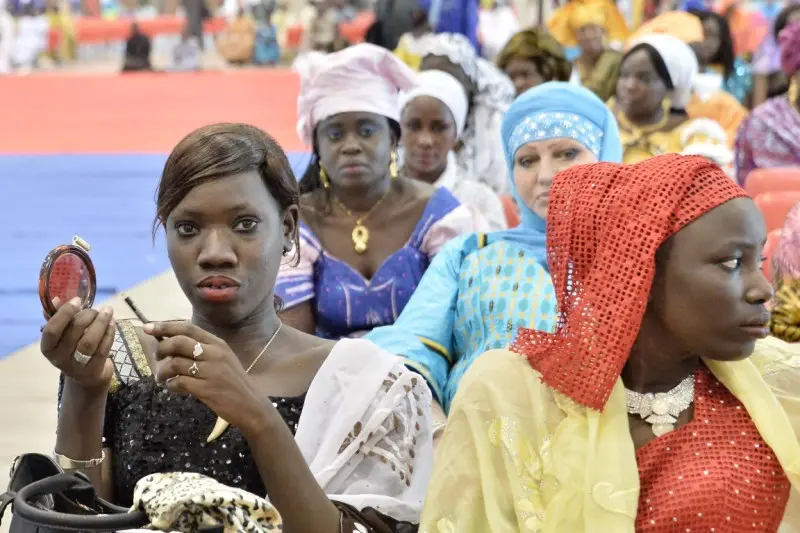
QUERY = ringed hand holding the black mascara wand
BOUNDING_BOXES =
[143,322,272,432]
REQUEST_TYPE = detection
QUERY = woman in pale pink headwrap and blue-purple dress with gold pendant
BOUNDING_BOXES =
[275,44,487,339]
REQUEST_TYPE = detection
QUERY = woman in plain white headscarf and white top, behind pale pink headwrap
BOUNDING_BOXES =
[400,70,507,231]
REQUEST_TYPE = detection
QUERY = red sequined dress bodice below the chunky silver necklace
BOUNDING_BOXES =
[636,367,791,533]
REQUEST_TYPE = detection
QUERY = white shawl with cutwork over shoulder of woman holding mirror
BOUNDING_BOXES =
[296,339,433,523]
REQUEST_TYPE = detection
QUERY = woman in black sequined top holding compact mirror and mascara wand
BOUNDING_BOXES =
[47,124,433,533]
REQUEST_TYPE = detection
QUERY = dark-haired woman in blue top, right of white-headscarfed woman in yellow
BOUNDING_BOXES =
[689,10,753,103]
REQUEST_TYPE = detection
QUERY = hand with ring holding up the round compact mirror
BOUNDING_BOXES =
[39,298,114,391]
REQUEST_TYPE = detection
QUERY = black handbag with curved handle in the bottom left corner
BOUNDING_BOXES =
[0,453,150,533]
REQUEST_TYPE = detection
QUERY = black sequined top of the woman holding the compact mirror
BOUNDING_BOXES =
[105,377,305,505]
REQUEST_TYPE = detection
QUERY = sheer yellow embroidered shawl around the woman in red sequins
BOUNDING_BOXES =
[421,338,800,533]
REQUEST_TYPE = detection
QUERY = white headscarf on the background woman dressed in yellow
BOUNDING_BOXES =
[630,33,699,109]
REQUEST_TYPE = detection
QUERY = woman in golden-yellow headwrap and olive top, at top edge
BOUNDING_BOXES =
[570,3,622,102]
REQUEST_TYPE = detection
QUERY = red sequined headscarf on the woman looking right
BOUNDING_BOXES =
[511,154,747,411]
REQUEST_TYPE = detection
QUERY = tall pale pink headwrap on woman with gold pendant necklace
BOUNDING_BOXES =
[297,43,415,146]
